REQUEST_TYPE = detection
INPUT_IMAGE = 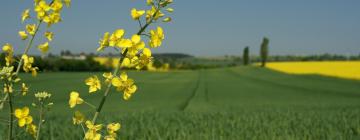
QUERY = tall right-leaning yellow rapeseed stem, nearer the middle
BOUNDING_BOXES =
[69,0,174,140]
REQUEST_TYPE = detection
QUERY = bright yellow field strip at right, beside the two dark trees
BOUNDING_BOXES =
[266,61,360,80]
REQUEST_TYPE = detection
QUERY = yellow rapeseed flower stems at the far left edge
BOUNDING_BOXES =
[0,0,71,139]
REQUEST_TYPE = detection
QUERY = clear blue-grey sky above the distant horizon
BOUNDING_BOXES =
[0,0,360,56]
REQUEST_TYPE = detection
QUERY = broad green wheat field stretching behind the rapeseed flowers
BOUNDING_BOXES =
[0,67,360,140]
